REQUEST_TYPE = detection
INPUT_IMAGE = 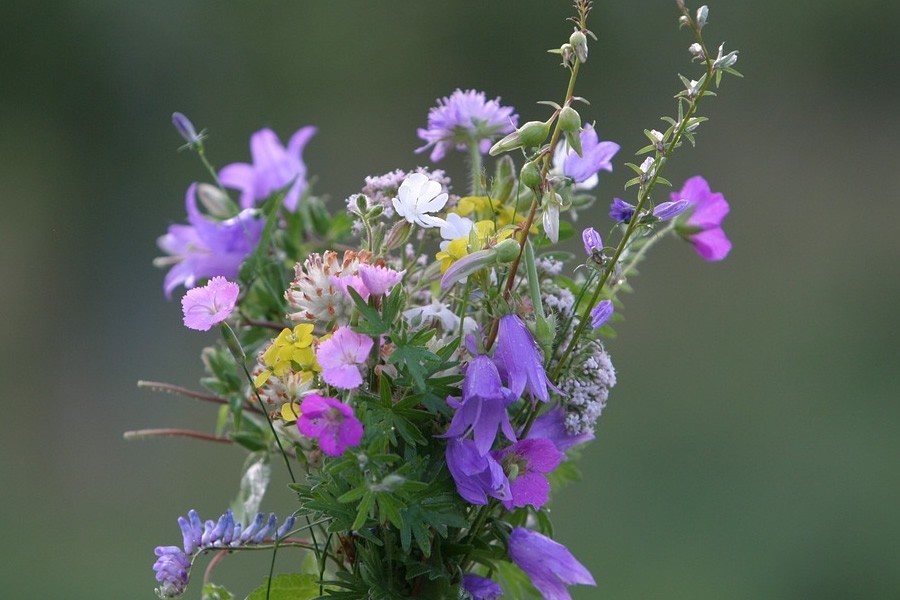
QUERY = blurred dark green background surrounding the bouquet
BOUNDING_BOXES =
[0,0,900,600]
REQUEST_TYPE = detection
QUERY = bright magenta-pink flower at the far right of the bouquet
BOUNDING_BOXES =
[671,175,731,261]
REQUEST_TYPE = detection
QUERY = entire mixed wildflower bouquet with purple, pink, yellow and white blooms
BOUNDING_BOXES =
[132,0,737,600]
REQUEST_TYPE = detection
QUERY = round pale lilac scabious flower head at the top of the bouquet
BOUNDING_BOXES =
[416,90,519,162]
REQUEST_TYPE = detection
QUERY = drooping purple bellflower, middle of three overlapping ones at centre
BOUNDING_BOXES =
[440,354,516,456]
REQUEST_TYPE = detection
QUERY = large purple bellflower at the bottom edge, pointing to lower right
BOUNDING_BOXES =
[509,527,597,600]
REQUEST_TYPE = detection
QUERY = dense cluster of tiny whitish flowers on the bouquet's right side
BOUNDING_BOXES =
[559,340,616,435]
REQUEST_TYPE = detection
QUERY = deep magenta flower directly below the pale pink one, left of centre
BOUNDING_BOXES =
[297,394,363,456]
